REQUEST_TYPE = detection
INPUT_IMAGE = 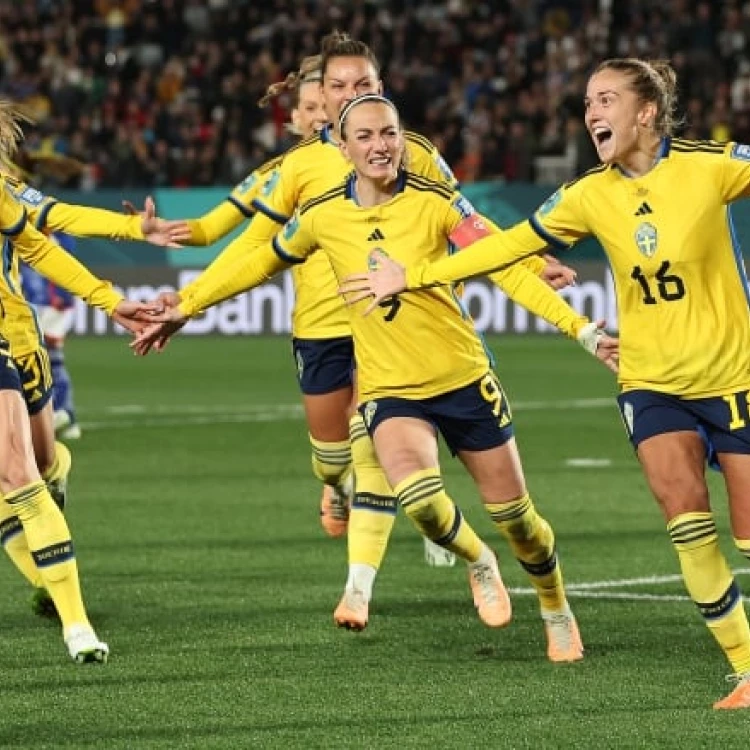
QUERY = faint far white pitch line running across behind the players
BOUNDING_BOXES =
[80,398,614,430]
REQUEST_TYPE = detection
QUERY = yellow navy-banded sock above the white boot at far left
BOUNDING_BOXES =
[5,480,89,629]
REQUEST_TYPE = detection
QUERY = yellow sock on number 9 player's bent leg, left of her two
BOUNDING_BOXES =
[393,469,484,563]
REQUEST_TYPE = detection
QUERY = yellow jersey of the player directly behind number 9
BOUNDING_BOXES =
[249,126,456,339]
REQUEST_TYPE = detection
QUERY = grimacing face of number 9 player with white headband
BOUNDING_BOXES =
[341,102,404,182]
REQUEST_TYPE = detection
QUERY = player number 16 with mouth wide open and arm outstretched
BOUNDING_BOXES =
[343,59,750,709]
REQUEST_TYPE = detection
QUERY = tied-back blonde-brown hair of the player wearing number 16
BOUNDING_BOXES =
[594,57,680,136]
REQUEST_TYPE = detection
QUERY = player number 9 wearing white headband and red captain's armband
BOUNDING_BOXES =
[134,94,610,661]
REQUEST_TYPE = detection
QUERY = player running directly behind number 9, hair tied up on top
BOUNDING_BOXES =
[167,32,575,568]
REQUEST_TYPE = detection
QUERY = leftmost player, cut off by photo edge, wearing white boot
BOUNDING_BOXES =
[0,169,160,663]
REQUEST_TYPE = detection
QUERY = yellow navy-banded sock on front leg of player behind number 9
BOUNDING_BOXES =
[347,414,397,570]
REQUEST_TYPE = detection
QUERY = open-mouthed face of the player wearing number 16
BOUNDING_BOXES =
[584,69,656,164]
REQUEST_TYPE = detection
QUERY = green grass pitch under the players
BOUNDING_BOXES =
[0,337,750,750]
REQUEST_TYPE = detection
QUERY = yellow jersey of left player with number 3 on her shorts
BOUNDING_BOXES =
[0,175,143,356]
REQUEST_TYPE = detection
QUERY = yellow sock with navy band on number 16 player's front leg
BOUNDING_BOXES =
[667,513,750,674]
